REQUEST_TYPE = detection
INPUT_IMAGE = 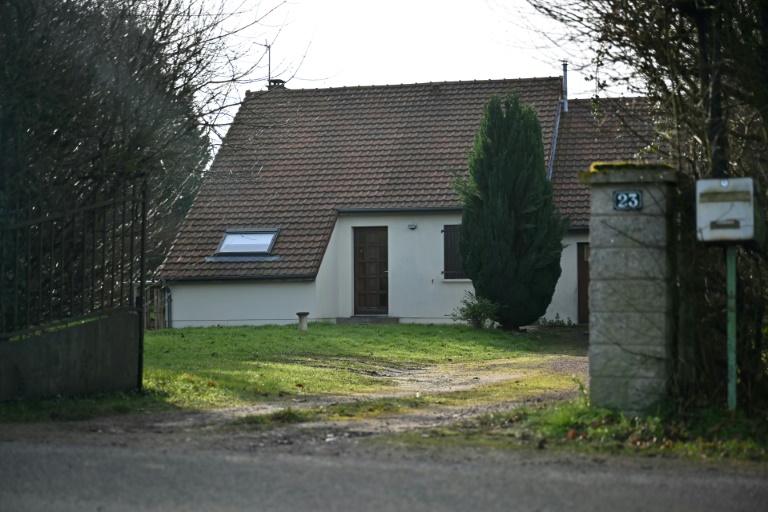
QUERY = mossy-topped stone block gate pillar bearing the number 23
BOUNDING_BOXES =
[581,163,676,415]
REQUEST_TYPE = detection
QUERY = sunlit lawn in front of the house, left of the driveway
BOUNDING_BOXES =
[0,324,586,421]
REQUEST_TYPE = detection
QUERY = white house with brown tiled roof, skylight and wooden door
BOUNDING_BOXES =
[159,71,656,327]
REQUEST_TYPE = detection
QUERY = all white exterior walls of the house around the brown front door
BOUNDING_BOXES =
[169,216,588,327]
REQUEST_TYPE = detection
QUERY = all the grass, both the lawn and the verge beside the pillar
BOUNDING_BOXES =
[0,324,768,463]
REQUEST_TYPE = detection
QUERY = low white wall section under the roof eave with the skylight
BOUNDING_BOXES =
[169,280,317,327]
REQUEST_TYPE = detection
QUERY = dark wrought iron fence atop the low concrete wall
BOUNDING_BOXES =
[0,180,147,341]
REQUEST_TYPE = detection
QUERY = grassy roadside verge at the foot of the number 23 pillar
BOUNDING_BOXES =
[386,397,768,463]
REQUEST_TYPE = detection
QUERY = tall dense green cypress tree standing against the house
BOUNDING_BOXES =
[454,94,568,329]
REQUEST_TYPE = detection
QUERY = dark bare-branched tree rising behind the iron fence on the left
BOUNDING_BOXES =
[0,0,279,263]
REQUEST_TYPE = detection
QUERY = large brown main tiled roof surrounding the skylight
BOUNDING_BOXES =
[160,77,561,279]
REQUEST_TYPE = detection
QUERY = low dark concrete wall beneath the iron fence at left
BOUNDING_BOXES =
[0,312,140,401]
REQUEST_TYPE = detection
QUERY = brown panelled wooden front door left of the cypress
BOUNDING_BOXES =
[354,227,389,315]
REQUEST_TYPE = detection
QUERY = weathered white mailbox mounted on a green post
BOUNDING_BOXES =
[696,178,755,242]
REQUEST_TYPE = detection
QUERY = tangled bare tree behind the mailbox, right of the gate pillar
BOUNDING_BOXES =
[528,0,768,408]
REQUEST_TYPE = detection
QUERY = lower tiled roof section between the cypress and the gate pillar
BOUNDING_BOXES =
[552,98,653,229]
